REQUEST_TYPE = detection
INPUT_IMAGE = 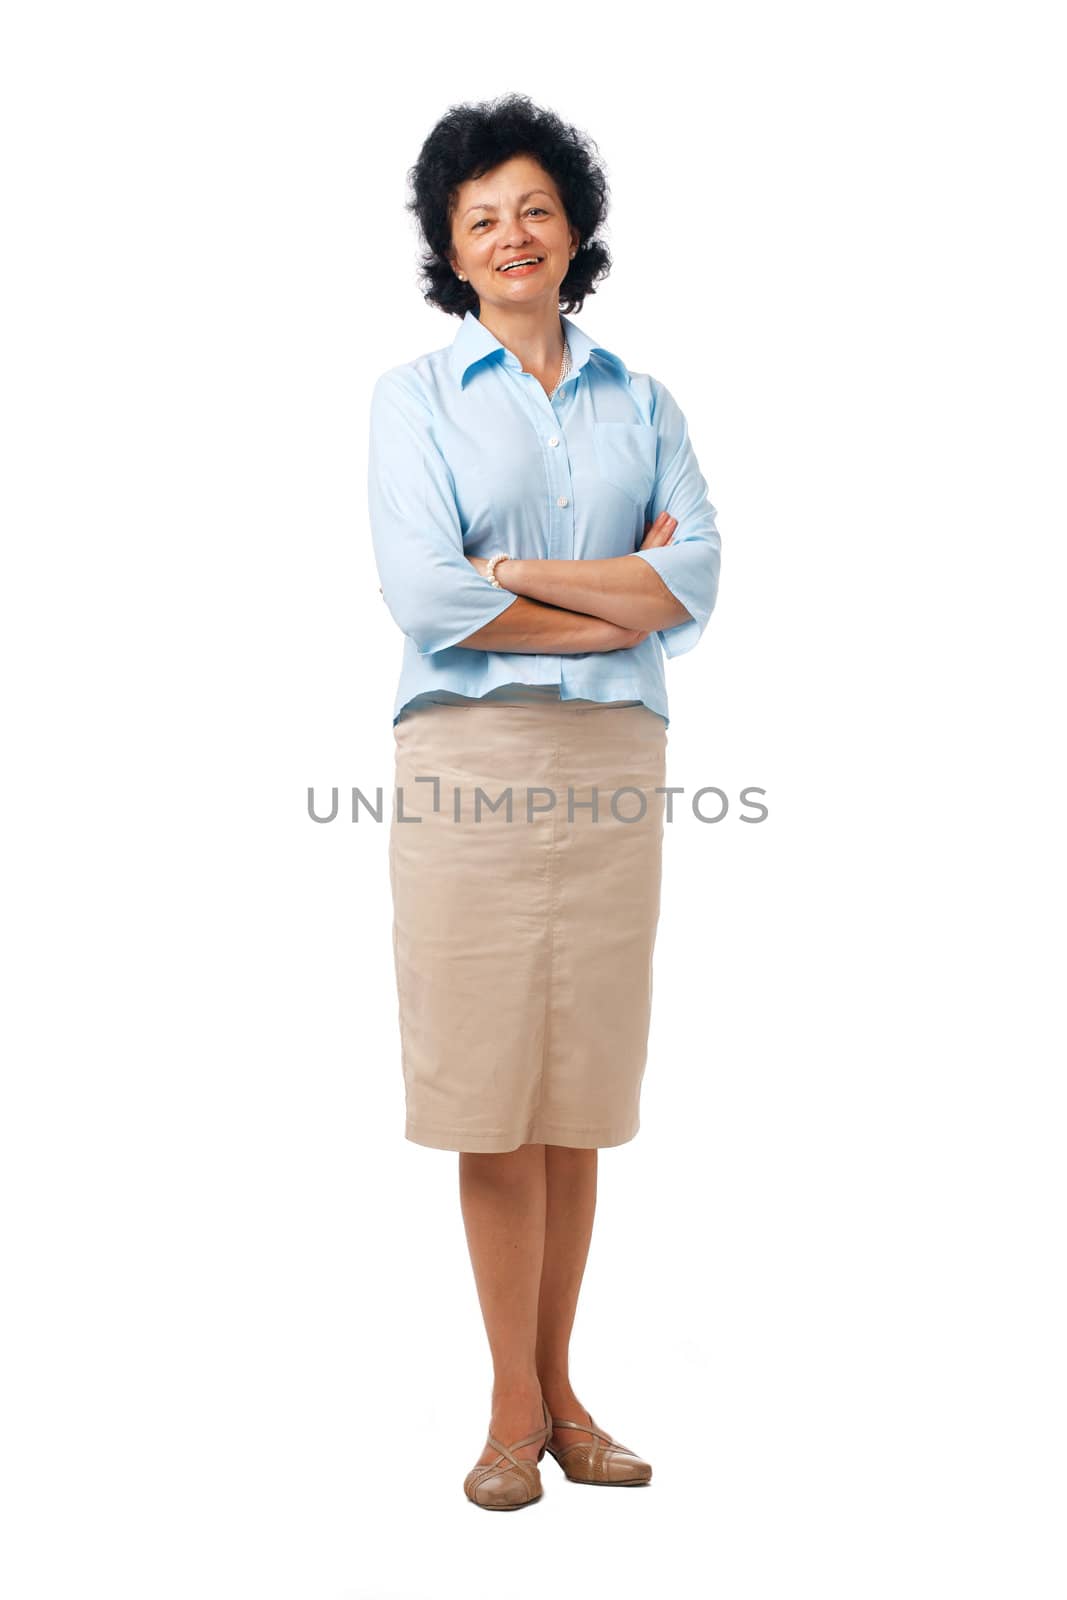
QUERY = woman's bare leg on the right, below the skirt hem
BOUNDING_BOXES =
[537,1144,598,1450]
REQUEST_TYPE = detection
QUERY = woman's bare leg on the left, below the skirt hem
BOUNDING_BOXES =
[459,1144,547,1466]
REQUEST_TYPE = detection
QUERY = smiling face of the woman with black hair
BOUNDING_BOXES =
[451,155,579,307]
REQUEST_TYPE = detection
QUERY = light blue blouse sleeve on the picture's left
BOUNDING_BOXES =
[368,368,518,656]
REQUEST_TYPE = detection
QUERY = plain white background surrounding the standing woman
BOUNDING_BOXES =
[0,0,1067,1600]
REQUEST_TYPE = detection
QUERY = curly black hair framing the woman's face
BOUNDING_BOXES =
[405,94,611,317]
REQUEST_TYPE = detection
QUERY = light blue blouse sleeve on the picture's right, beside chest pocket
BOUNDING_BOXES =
[635,379,721,656]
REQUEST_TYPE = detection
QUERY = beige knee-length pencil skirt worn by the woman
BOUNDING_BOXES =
[389,696,667,1150]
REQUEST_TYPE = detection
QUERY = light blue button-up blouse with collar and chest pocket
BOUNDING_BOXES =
[368,310,720,723]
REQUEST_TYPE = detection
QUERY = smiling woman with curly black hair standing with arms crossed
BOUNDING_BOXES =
[370,96,720,1509]
